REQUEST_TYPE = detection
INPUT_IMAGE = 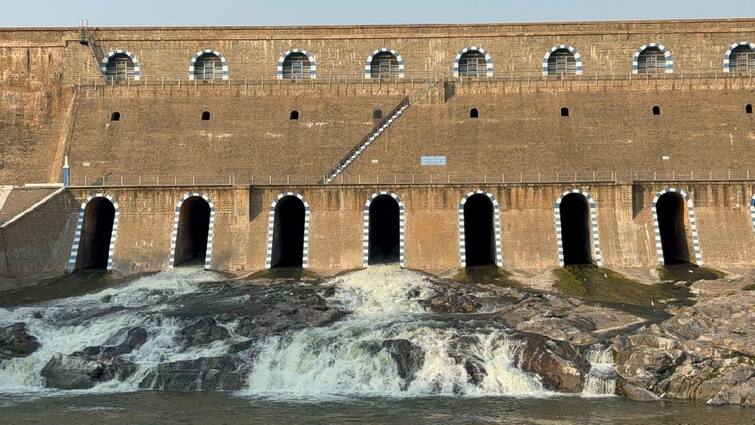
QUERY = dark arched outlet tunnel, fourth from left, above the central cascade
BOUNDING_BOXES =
[369,195,401,264]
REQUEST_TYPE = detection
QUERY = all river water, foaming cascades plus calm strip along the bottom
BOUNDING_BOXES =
[0,266,755,424]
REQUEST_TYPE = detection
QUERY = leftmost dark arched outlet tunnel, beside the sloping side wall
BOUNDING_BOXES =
[76,197,115,270]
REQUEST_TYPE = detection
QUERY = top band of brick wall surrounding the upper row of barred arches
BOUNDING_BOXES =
[0,19,755,81]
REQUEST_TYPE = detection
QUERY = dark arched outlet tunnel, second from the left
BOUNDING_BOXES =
[173,196,210,266]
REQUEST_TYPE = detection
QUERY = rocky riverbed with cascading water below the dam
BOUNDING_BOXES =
[0,266,755,405]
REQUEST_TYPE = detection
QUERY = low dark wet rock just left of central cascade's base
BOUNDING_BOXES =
[139,355,249,392]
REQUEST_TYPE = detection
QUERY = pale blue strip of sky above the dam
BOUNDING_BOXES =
[0,0,755,27]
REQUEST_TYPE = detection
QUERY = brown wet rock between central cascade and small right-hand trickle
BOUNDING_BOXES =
[516,334,590,393]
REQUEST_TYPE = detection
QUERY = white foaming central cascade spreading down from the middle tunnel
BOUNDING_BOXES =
[244,266,551,399]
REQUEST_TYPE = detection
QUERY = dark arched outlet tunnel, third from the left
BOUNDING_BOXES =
[270,196,305,268]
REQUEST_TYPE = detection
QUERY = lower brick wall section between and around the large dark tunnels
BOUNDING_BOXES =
[62,182,755,275]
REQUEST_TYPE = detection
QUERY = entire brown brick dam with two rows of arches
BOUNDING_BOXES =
[0,19,755,278]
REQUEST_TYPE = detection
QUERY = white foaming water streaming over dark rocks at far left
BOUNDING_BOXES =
[0,269,225,393]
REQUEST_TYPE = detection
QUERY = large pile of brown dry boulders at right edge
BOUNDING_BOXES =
[612,277,755,405]
